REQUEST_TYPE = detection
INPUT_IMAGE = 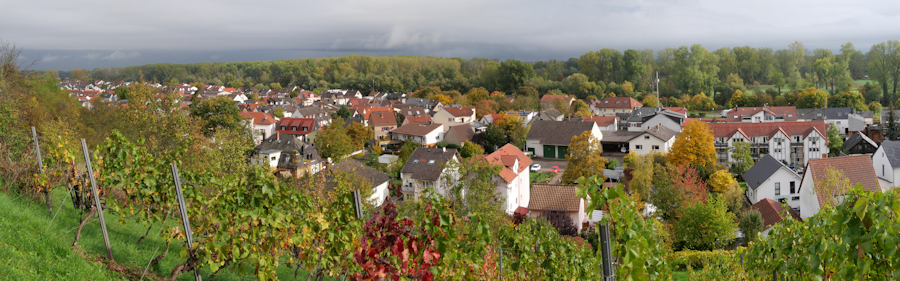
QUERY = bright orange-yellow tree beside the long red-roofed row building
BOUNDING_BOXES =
[666,120,716,167]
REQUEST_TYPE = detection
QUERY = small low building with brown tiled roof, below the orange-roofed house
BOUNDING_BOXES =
[528,183,585,232]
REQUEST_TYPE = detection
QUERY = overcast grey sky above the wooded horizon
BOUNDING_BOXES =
[0,0,900,70]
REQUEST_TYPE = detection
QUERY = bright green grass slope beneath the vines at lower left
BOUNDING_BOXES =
[0,188,334,280]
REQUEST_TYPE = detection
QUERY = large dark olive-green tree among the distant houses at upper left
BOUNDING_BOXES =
[191,96,243,134]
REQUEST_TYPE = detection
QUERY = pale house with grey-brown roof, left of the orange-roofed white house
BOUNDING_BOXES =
[400,147,459,199]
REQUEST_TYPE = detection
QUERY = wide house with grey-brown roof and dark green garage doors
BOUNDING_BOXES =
[525,120,603,159]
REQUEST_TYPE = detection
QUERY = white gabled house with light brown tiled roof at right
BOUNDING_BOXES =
[798,155,881,219]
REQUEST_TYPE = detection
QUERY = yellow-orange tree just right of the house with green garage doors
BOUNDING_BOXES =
[561,131,607,183]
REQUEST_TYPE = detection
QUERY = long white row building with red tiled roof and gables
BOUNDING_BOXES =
[709,121,828,168]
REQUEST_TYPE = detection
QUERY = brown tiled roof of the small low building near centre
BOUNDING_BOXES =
[528,184,581,212]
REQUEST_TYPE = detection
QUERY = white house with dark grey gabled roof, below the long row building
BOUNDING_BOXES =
[742,155,803,211]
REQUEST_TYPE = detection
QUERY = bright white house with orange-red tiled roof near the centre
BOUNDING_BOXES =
[485,144,531,214]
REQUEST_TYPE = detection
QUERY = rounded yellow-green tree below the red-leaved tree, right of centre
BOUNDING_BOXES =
[674,195,737,251]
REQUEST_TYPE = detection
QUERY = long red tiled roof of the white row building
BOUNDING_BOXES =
[708,121,827,138]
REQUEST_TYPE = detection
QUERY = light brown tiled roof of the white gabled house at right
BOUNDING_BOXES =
[800,155,881,206]
